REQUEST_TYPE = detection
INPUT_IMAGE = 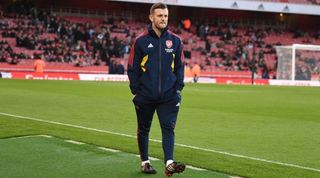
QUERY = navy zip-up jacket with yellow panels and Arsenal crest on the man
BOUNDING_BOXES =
[128,25,184,100]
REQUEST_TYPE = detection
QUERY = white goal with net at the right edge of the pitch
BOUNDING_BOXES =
[275,44,320,80]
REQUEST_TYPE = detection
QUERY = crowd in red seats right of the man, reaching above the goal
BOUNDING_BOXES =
[175,15,319,78]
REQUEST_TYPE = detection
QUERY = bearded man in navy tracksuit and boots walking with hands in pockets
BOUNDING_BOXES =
[128,3,185,176]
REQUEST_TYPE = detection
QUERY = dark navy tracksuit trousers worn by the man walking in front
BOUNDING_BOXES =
[133,94,181,161]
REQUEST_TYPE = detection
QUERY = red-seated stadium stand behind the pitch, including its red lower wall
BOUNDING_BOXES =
[0,1,320,77]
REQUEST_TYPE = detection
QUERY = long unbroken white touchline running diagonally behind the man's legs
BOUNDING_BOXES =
[0,112,320,172]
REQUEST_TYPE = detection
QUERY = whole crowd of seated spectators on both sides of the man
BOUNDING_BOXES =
[0,1,320,78]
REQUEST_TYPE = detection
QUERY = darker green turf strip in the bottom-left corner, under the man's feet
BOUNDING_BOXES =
[0,136,227,178]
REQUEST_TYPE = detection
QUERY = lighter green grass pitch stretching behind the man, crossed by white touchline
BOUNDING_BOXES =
[0,79,320,177]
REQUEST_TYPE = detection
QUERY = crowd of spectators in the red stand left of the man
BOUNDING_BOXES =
[0,3,132,74]
